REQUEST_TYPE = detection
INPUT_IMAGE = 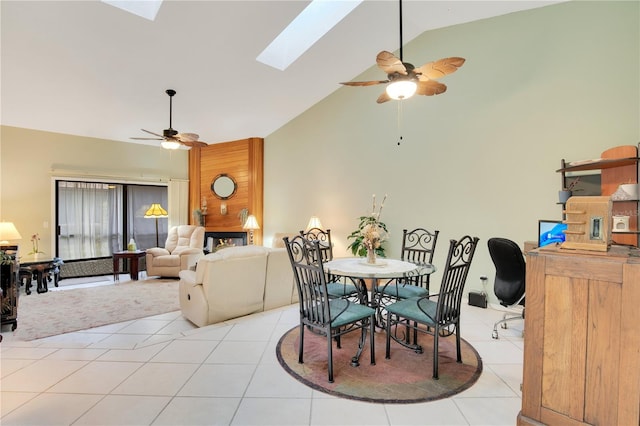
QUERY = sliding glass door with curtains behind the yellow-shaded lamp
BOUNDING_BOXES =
[56,180,167,260]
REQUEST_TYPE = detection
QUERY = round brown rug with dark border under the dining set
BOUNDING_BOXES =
[276,326,482,404]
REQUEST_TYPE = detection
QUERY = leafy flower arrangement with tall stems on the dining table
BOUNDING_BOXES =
[347,194,389,263]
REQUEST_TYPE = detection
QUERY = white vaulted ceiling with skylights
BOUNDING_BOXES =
[0,0,556,143]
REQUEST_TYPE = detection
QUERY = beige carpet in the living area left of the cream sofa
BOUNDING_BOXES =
[15,279,180,340]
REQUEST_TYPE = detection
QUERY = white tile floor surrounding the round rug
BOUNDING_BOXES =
[0,278,523,426]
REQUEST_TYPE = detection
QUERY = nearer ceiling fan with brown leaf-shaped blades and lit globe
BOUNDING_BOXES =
[340,0,465,104]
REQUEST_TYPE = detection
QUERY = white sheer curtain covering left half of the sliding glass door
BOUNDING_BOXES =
[57,181,123,259]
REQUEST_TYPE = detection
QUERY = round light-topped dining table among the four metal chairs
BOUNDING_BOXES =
[323,257,436,319]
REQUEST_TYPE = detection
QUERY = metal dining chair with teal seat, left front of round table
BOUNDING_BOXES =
[284,236,376,382]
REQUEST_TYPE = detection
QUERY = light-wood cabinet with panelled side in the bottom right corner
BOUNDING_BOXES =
[518,246,640,425]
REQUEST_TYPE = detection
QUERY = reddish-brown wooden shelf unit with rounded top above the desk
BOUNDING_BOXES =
[557,145,640,247]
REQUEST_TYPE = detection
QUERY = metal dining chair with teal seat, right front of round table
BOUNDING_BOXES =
[385,236,478,379]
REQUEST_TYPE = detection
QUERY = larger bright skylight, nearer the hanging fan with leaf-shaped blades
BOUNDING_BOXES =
[256,0,363,71]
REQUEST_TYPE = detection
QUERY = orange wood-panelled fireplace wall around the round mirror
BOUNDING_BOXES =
[189,138,264,245]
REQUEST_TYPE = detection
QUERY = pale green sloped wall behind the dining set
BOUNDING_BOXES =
[264,1,640,300]
